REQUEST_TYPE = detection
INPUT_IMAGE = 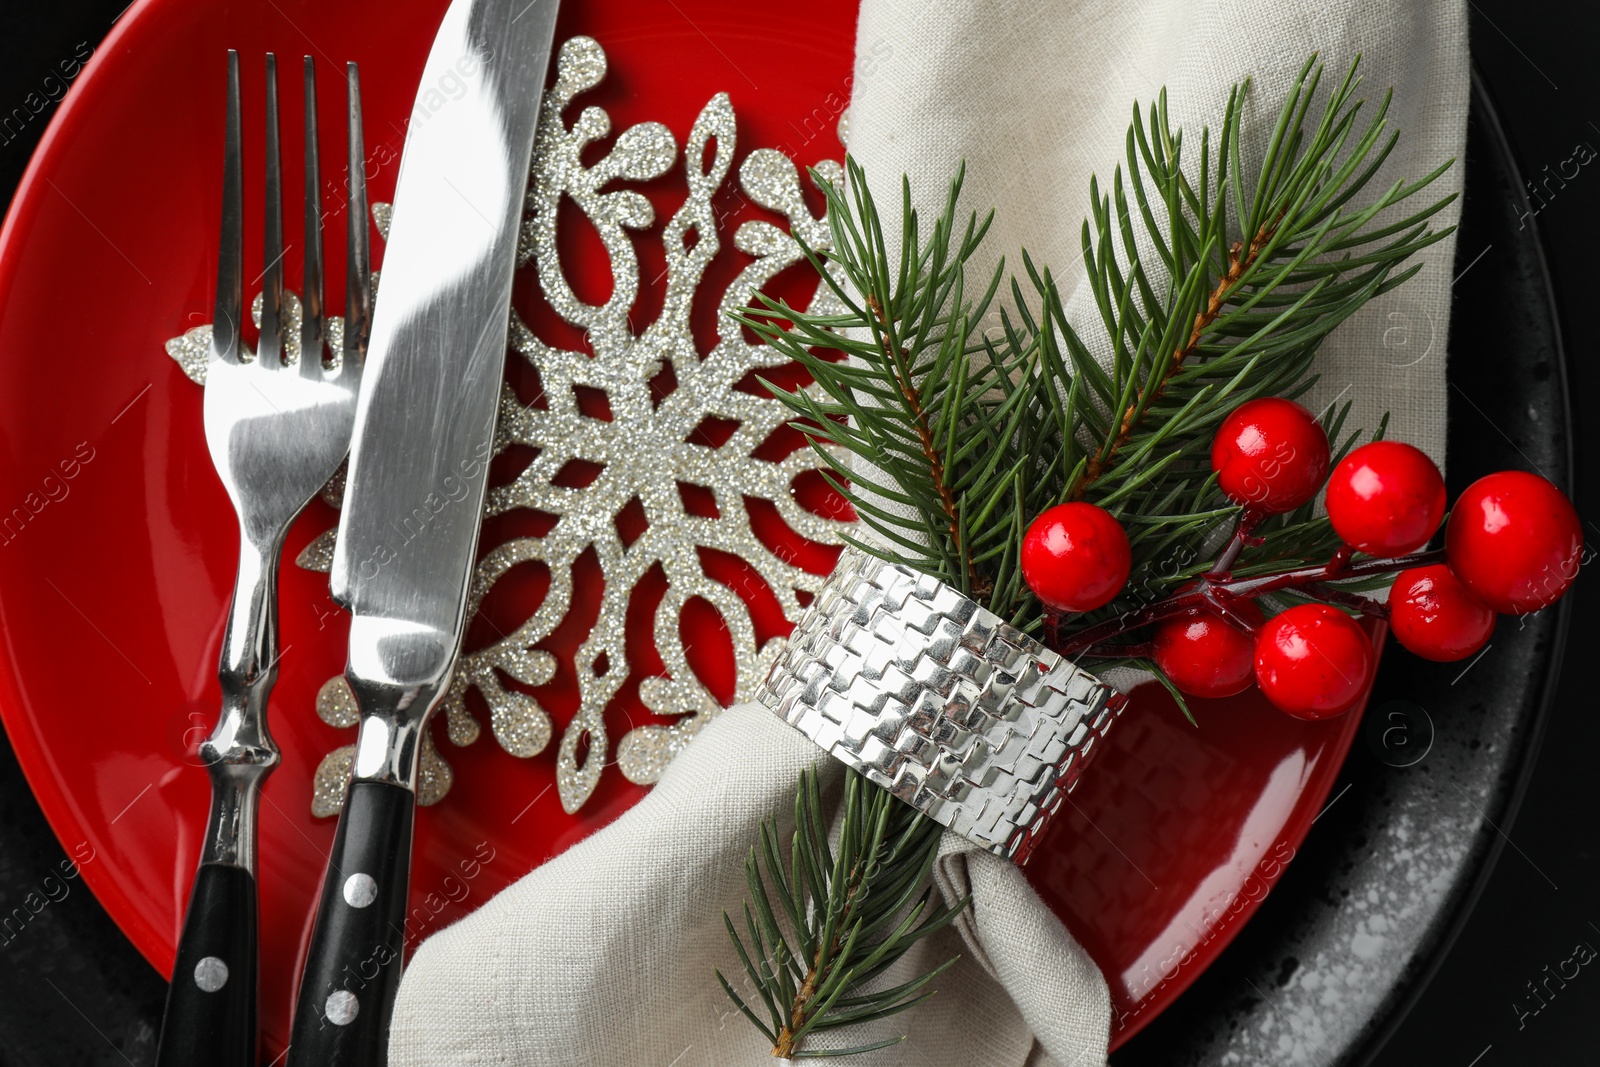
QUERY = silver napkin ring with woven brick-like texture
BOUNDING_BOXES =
[757,549,1126,864]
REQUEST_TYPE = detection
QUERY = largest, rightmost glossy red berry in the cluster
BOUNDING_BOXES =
[1445,470,1584,614]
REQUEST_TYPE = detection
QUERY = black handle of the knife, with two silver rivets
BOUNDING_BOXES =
[288,781,416,1067]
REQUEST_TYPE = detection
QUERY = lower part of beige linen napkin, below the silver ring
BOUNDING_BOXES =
[389,705,1109,1067]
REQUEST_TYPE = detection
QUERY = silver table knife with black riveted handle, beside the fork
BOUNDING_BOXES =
[288,0,558,1067]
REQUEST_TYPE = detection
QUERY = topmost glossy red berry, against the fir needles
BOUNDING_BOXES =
[1211,397,1328,515]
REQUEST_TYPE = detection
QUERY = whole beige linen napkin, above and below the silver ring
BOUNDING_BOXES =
[390,0,1467,1067]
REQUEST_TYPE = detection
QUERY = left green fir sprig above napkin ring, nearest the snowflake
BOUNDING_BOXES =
[733,160,1014,593]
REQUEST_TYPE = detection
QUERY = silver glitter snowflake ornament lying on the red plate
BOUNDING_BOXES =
[168,37,843,814]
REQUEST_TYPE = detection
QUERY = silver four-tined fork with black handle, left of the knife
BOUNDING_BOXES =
[157,51,371,1067]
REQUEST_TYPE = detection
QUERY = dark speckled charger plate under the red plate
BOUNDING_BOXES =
[0,80,1573,1067]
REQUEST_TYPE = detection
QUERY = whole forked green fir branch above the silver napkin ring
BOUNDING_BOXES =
[739,58,1450,630]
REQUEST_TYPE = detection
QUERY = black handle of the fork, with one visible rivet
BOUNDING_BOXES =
[155,864,256,1067]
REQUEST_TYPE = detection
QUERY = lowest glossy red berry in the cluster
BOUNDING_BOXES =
[1256,603,1373,718]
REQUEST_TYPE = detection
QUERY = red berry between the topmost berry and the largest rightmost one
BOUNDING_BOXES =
[1328,442,1445,558]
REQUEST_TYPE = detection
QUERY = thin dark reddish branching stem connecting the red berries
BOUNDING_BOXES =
[1045,550,1445,659]
